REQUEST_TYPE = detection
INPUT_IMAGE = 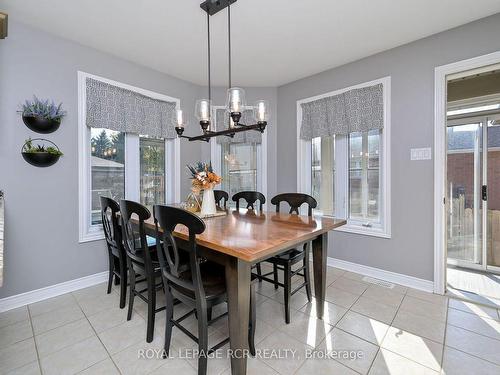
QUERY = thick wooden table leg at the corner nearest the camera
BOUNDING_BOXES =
[225,257,251,375]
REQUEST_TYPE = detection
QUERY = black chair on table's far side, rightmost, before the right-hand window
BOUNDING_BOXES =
[260,193,318,324]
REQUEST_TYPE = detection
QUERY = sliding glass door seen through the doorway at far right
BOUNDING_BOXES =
[447,116,500,270]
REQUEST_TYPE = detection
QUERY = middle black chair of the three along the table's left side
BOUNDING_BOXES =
[120,200,165,342]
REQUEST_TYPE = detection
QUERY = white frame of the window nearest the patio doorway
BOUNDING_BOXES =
[297,76,391,238]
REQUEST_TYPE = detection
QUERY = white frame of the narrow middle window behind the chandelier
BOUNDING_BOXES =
[210,106,267,209]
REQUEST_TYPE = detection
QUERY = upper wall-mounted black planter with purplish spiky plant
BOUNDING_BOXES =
[18,96,66,134]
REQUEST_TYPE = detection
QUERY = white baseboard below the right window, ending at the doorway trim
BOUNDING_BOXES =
[328,257,434,293]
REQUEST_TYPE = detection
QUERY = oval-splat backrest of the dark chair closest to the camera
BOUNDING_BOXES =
[153,205,205,300]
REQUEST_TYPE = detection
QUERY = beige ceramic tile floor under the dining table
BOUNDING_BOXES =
[0,268,500,375]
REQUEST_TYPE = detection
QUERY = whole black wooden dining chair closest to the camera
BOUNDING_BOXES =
[153,205,256,375]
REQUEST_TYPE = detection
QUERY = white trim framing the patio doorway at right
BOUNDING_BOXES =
[434,51,500,294]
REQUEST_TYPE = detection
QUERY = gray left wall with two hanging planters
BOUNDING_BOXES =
[0,20,201,298]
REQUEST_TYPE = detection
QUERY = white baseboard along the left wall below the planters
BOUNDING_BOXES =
[0,271,108,312]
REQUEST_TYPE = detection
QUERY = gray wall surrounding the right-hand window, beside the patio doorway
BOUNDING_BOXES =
[277,14,500,280]
